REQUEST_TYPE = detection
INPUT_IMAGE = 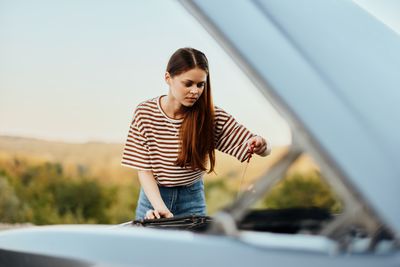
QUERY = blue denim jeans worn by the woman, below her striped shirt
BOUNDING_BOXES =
[135,178,207,220]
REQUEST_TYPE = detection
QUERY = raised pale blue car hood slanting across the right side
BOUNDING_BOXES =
[181,0,400,239]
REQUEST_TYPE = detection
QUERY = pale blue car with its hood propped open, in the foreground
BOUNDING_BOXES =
[0,0,400,266]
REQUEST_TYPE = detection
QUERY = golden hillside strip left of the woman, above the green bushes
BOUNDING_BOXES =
[0,136,136,184]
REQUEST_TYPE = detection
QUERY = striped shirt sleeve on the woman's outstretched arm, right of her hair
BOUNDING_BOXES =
[215,107,256,162]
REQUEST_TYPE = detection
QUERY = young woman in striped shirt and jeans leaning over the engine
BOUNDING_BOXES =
[121,47,271,220]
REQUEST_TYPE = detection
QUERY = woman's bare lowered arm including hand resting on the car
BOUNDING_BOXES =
[138,170,173,219]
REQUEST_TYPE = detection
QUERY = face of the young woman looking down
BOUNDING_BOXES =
[165,68,207,107]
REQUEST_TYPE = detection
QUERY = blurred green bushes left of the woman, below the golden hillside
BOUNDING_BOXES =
[0,162,137,225]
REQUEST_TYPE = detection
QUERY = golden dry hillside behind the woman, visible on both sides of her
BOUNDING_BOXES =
[0,136,315,184]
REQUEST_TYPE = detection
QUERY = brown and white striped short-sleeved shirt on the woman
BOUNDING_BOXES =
[121,96,255,187]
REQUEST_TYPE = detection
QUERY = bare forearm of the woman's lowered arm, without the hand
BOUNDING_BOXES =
[138,171,168,210]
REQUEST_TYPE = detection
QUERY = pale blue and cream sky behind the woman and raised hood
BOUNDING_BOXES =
[0,0,400,145]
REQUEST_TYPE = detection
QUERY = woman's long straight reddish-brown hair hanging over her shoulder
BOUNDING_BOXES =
[167,47,215,173]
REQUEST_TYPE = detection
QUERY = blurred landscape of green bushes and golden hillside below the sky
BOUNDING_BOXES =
[0,138,342,225]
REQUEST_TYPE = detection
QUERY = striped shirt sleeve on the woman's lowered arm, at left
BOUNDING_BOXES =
[121,107,152,170]
